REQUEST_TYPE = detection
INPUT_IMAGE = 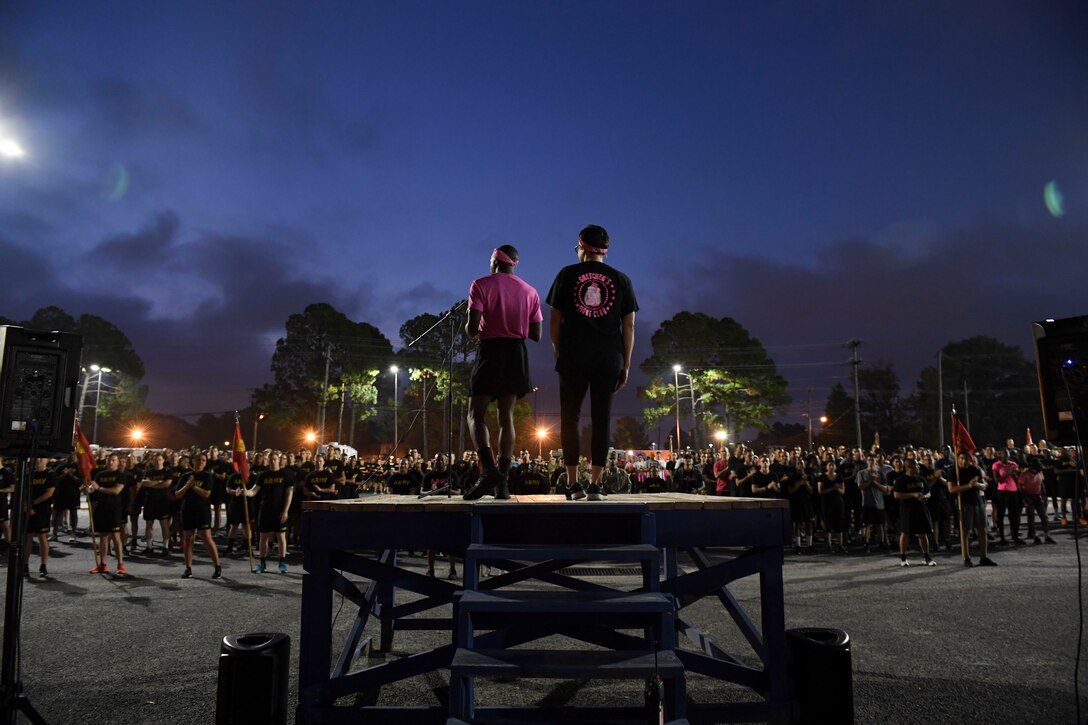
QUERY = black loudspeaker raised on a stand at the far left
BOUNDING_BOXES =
[0,325,83,456]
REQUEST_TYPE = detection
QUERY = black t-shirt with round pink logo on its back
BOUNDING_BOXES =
[547,261,639,372]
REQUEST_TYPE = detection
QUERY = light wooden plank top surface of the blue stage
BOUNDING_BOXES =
[302,493,790,514]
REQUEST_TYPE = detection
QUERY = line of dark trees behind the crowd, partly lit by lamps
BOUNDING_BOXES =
[0,300,1041,454]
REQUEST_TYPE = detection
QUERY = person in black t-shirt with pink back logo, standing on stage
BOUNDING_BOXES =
[547,224,639,501]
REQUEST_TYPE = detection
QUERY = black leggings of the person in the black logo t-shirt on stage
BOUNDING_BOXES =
[559,370,619,466]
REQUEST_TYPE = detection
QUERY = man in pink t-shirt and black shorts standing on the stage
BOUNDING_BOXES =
[465,244,544,501]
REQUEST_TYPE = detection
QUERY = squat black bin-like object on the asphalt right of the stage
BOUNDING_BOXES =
[786,627,854,725]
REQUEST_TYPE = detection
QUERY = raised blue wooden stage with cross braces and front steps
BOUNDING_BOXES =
[297,493,793,723]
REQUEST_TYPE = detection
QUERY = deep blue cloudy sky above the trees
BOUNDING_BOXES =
[0,0,1088,426]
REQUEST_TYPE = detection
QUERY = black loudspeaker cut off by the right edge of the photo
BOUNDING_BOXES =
[1031,316,1088,445]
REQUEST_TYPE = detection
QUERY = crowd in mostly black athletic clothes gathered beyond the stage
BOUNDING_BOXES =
[0,431,1088,578]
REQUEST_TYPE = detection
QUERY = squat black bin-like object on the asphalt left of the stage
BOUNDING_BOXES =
[215,632,290,725]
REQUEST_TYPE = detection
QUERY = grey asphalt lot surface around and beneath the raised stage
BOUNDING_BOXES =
[2,511,1088,725]
